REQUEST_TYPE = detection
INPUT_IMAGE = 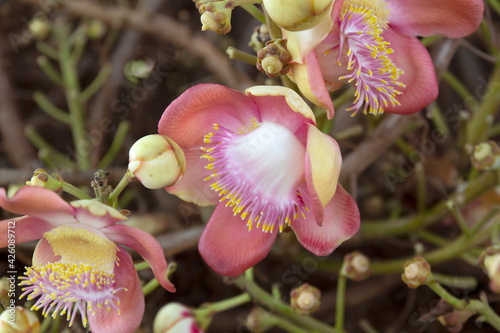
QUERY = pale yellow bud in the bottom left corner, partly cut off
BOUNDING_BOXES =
[0,306,40,333]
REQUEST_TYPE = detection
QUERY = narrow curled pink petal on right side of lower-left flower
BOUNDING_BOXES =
[102,224,175,292]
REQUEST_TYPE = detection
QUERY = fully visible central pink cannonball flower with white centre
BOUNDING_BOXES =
[158,84,360,276]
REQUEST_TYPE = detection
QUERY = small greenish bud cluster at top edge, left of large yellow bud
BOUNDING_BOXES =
[195,0,234,34]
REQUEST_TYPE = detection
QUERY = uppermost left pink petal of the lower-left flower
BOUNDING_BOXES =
[0,186,75,225]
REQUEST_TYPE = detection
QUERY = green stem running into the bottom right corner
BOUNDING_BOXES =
[426,273,500,331]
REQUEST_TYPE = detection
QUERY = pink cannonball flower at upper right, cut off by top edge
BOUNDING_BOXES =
[283,0,484,118]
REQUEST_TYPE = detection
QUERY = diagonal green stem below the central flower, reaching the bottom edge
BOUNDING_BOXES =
[233,275,338,333]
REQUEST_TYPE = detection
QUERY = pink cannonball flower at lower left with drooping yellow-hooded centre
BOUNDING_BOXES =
[0,186,175,333]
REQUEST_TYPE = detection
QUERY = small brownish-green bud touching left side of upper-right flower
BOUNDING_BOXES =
[256,39,291,78]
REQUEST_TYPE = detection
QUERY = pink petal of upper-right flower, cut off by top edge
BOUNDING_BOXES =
[387,0,484,38]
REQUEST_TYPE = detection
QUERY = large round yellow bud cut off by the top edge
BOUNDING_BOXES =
[263,0,334,31]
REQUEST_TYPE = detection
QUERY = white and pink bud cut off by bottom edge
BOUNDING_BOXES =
[153,302,203,333]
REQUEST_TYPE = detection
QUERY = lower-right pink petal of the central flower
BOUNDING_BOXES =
[291,184,360,256]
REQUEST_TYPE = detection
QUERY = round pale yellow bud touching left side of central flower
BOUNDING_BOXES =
[128,134,186,189]
